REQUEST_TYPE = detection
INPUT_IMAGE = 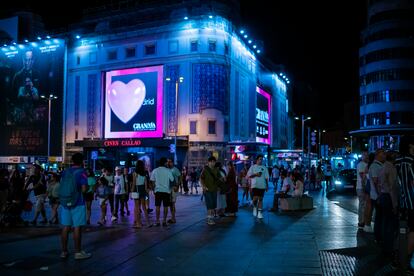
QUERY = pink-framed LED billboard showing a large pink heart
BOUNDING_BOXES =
[105,66,163,138]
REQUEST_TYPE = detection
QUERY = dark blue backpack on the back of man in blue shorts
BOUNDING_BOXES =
[59,169,80,207]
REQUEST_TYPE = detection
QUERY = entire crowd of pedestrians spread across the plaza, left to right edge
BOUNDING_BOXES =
[0,135,414,266]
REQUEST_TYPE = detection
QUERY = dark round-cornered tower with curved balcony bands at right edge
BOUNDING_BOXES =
[351,0,414,151]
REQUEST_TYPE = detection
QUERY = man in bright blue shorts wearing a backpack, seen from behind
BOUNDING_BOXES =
[59,153,92,260]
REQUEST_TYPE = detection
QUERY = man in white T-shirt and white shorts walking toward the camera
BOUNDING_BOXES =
[247,154,269,219]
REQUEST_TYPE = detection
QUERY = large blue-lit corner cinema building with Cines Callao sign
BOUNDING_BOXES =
[63,1,293,170]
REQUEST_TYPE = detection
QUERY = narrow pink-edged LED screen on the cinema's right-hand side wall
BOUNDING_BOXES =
[256,87,272,145]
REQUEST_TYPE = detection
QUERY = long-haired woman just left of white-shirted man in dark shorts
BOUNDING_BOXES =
[130,160,152,228]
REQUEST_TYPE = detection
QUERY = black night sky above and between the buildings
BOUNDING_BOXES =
[0,0,366,128]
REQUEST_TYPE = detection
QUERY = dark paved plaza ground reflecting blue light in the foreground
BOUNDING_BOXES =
[0,187,388,275]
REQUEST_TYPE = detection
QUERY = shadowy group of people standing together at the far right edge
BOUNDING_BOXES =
[357,137,414,272]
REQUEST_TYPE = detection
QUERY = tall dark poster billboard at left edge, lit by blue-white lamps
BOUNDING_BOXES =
[0,39,65,156]
